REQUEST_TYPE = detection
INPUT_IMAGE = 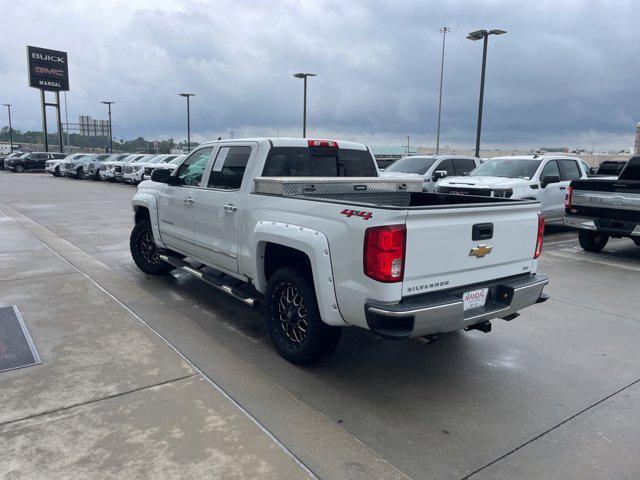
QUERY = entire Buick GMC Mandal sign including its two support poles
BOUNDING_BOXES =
[27,46,69,153]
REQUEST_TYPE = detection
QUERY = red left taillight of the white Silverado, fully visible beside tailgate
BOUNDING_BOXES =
[364,225,407,283]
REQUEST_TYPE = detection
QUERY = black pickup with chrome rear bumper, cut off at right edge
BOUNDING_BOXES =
[564,156,640,252]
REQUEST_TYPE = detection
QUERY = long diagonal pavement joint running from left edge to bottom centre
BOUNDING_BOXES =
[0,203,319,480]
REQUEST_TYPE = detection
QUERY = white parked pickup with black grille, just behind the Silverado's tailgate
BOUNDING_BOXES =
[436,155,587,221]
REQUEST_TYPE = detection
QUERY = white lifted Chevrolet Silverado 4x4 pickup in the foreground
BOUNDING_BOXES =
[130,138,548,363]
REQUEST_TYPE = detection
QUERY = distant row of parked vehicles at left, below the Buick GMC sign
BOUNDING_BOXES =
[2,152,185,185]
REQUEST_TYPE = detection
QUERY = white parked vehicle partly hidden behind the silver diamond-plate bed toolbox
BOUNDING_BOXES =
[381,155,480,192]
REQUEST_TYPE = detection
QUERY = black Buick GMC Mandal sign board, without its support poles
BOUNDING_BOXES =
[27,46,69,92]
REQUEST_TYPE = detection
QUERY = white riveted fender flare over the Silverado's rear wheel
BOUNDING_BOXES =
[250,221,346,326]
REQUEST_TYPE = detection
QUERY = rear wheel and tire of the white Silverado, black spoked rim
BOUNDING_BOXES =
[265,267,342,365]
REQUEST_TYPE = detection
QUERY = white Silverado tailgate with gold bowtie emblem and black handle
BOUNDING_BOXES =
[402,203,539,296]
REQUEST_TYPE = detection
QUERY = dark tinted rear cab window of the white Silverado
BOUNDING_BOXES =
[262,147,378,177]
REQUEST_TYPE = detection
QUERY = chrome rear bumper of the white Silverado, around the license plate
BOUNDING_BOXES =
[365,275,549,340]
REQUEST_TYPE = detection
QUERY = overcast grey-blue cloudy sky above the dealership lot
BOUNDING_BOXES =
[0,0,640,149]
